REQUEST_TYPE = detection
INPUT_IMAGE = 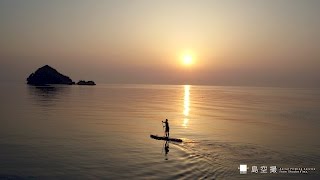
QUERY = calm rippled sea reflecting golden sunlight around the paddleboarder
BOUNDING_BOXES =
[0,84,320,179]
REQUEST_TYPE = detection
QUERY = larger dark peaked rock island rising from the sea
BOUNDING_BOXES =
[27,65,75,85]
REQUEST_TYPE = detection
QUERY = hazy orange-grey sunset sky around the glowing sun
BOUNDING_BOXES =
[0,0,320,87]
